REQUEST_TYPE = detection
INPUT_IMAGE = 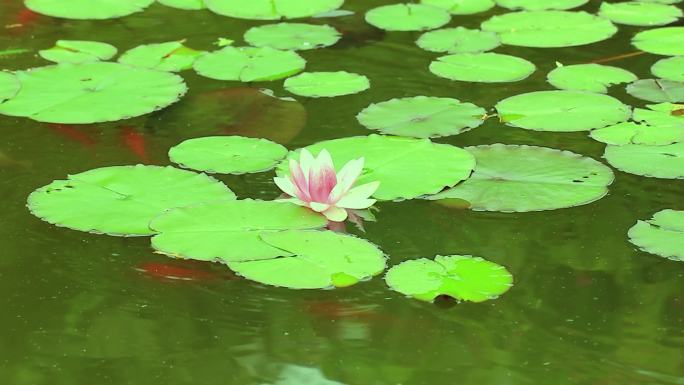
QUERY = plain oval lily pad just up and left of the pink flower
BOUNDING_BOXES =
[169,136,287,174]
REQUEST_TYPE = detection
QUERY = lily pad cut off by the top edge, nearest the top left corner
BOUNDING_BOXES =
[24,0,154,20]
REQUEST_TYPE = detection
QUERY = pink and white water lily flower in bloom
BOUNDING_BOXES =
[273,149,380,222]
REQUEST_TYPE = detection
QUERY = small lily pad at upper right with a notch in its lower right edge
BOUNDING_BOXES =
[547,64,637,94]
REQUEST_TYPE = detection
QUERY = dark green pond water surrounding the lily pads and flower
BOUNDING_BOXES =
[0,0,684,385]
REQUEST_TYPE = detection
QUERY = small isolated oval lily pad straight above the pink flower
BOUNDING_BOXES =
[285,71,370,98]
